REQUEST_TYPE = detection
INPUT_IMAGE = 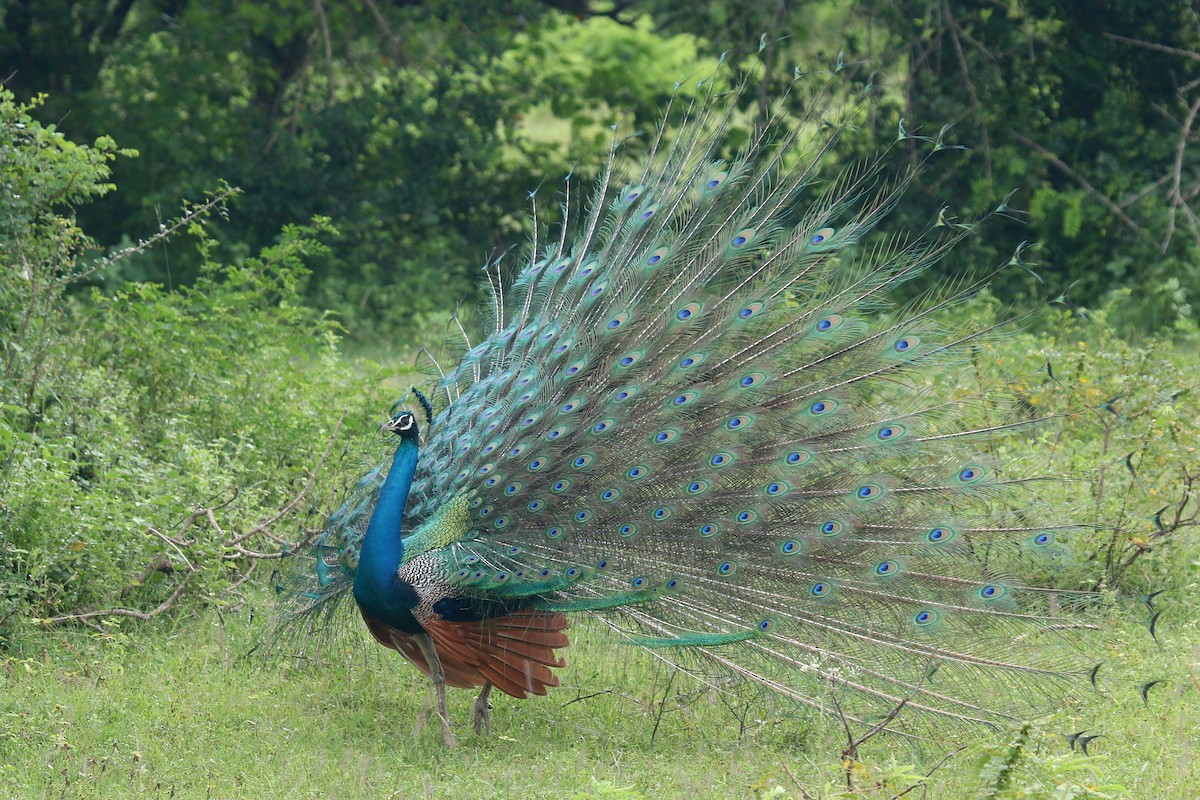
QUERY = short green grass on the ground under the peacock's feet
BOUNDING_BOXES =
[0,599,1200,800]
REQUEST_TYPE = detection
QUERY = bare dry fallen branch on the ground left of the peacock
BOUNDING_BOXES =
[40,409,346,625]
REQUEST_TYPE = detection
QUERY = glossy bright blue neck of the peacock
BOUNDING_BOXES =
[354,439,418,618]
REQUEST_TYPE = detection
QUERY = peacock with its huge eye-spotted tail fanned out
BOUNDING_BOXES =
[278,71,1123,746]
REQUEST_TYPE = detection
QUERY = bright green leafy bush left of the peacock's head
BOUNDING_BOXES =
[0,89,400,642]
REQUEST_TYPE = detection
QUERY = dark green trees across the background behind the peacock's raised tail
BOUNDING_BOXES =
[7,0,1200,341]
